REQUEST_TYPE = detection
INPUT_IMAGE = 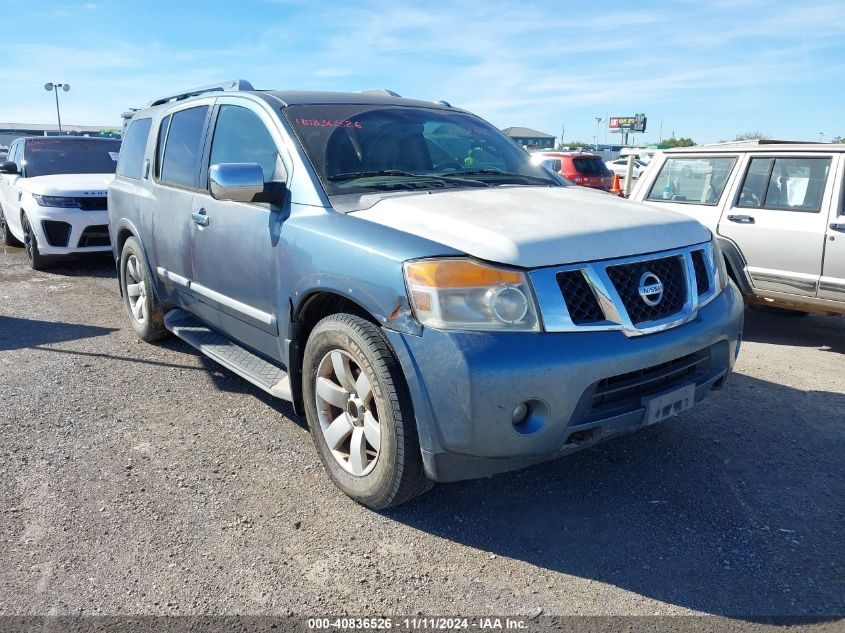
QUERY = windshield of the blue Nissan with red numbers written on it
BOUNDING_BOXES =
[284,104,564,195]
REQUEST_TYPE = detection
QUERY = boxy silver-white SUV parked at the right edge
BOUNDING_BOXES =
[631,142,845,314]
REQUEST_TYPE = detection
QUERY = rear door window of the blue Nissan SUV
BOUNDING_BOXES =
[161,106,208,187]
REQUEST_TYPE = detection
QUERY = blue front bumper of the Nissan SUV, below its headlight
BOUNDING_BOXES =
[387,283,743,481]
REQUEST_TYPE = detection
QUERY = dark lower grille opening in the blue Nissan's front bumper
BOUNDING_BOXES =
[590,347,710,416]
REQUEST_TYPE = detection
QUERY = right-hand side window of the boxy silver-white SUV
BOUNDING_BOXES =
[737,157,830,213]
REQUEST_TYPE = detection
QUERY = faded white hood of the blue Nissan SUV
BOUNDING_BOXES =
[354,187,710,268]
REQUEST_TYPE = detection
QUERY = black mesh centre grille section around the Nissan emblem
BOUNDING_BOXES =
[607,255,687,325]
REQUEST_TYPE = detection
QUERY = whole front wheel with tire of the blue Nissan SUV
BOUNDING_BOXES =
[302,314,433,510]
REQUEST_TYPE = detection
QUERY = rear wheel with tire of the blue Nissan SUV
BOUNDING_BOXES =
[119,237,169,343]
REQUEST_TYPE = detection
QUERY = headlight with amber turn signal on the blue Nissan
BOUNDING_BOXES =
[404,259,540,332]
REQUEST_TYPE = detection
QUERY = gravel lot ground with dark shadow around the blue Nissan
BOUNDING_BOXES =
[0,250,845,623]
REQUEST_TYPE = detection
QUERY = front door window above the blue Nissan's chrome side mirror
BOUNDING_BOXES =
[211,105,285,182]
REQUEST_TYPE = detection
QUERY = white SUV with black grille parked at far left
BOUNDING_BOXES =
[0,136,120,270]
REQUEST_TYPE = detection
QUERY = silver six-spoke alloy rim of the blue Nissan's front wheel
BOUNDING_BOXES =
[314,349,381,477]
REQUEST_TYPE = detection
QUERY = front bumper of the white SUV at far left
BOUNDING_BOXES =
[26,205,111,256]
